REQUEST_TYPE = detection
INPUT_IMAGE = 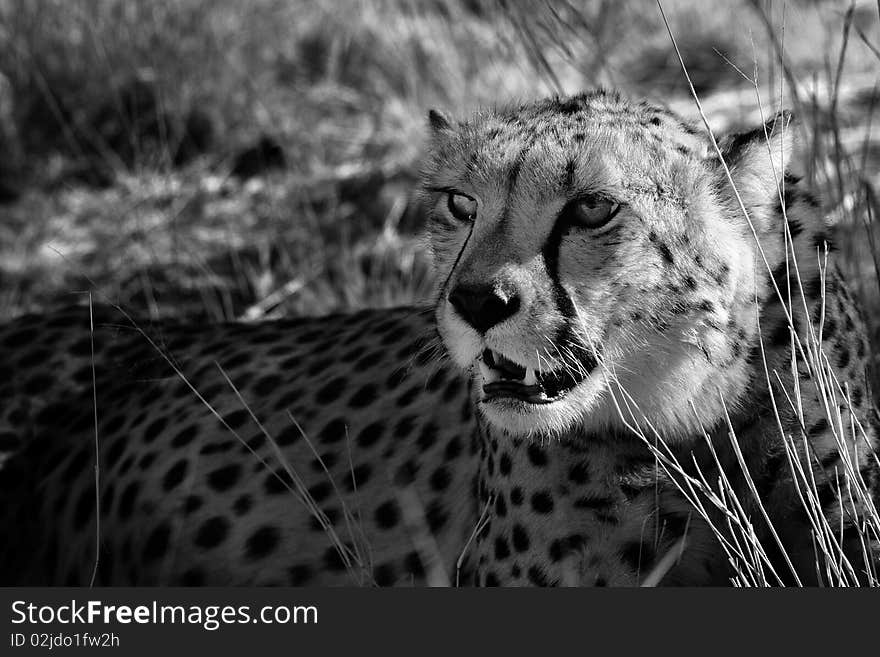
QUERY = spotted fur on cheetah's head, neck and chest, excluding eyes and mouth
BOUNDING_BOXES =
[425,88,877,584]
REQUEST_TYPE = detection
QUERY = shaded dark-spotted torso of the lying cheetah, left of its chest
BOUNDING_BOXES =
[3,308,476,585]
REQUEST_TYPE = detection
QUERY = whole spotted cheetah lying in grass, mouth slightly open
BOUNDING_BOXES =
[0,91,878,586]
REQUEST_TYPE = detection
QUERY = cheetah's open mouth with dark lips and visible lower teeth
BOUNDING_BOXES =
[477,349,597,404]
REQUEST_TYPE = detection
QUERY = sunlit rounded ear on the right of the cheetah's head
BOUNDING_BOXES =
[719,110,793,208]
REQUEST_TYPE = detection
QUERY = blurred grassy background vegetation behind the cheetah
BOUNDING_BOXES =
[0,0,880,362]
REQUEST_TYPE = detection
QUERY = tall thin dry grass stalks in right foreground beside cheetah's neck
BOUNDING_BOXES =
[644,0,880,586]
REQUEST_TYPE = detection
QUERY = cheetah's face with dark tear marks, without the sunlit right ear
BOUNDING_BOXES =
[424,93,792,435]
